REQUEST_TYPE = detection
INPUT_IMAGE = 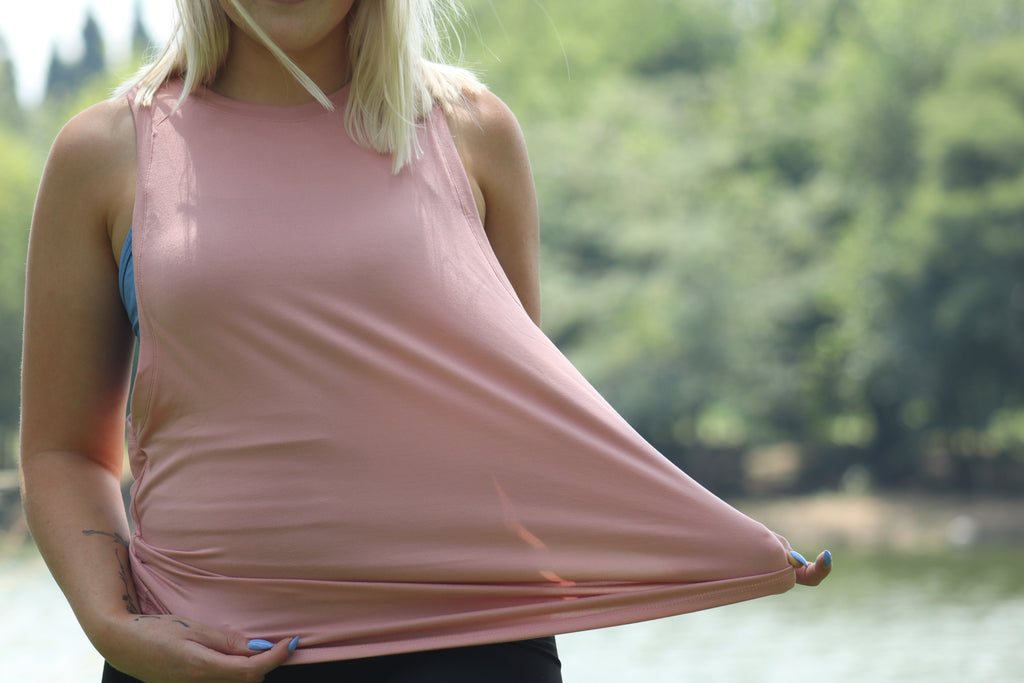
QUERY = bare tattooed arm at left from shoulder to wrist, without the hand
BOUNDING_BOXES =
[20,94,138,633]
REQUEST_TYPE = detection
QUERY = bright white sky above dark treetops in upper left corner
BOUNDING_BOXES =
[0,0,174,105]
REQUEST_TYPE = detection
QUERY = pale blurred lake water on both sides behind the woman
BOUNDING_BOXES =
[0,549,1024,683]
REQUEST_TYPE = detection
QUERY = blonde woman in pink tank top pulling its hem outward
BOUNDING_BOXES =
[22,0,830,681]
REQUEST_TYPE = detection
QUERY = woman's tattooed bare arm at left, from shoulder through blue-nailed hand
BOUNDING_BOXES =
[20,101,288,681]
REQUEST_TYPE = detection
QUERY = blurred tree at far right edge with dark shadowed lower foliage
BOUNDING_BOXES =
[878,38,1024,486]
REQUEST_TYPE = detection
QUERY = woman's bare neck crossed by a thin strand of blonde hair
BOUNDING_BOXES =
[210,25,349,105]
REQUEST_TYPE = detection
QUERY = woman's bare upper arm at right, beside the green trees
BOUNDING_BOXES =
[451,92,541,325]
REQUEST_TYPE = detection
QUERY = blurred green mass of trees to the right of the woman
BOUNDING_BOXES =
[467,0,1024,488]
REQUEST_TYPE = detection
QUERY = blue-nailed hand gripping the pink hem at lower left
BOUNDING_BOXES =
[95,614,298,683]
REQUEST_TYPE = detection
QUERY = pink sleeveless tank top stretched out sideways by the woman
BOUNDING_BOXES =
[121,78,794,664]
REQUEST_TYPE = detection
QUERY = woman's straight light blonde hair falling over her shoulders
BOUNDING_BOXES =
[121,0,483,172]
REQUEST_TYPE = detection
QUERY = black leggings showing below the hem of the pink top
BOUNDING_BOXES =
[102,637,562,683]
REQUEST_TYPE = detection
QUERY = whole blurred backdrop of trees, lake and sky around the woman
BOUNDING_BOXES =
[0,0,1024,683]
